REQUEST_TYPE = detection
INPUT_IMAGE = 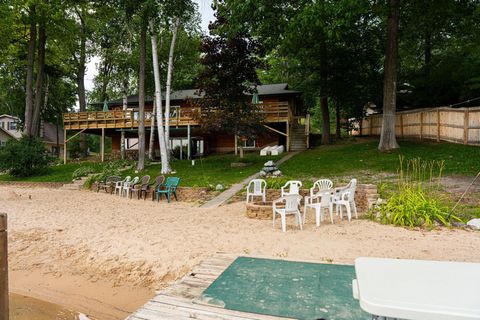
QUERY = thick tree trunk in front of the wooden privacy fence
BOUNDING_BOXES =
[378,0,400,151]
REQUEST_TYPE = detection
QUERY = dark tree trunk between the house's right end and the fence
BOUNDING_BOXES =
[319,32,330,144]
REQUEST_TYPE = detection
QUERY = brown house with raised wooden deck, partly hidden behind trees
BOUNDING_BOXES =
[64,83,309,162]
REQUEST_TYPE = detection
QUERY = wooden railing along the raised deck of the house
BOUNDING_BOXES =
[63,101,292,130]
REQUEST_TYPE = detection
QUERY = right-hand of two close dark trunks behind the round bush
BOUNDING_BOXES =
[31,22,47,136]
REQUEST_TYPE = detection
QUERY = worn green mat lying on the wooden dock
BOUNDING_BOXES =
[197,257,372,320]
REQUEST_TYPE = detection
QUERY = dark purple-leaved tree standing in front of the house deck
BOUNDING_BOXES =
[197,11,262,157]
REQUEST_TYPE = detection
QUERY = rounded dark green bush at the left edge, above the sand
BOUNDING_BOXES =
[0,137,52,177]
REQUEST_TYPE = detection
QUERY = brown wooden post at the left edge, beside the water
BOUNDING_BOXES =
[0,213,9,320]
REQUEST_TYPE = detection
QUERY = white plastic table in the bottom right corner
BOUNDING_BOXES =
[353,253,480,320]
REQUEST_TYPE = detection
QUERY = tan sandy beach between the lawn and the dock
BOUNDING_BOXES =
[0,186,480,320]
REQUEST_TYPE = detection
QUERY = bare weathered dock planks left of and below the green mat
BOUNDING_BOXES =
[127,254,294,320]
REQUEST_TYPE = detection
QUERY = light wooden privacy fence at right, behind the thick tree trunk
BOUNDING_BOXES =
[360,107,480,145]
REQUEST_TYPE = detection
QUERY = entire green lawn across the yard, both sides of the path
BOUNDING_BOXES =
[0,139,480,187]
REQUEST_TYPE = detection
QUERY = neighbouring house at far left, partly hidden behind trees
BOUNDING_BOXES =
[0,114,63,155]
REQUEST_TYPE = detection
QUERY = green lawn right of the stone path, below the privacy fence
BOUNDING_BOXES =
[280,140,480,184]
